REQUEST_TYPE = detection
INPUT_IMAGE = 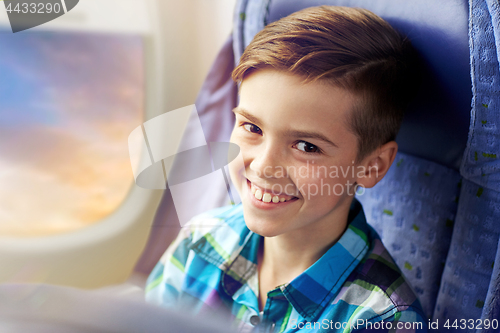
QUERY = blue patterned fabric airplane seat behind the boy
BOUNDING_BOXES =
[136,0,500,324]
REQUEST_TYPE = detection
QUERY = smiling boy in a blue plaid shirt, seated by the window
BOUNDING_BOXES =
[147,7,426,332]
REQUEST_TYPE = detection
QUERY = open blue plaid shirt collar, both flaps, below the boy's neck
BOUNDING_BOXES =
[191,199,370,321]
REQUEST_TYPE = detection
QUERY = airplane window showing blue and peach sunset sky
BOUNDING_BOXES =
[0,31,144,237]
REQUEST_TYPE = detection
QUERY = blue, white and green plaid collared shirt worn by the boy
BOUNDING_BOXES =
[146,200,427,333]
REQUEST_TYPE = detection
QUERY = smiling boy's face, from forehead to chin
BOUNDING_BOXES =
[230,69,359,239]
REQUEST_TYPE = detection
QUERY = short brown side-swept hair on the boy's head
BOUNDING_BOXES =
[232,6,419,160]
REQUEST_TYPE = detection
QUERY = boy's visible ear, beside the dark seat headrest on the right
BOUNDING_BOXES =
[356,141,398,188]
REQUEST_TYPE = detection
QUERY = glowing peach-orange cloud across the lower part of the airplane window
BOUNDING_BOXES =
[0,127,133,236]
